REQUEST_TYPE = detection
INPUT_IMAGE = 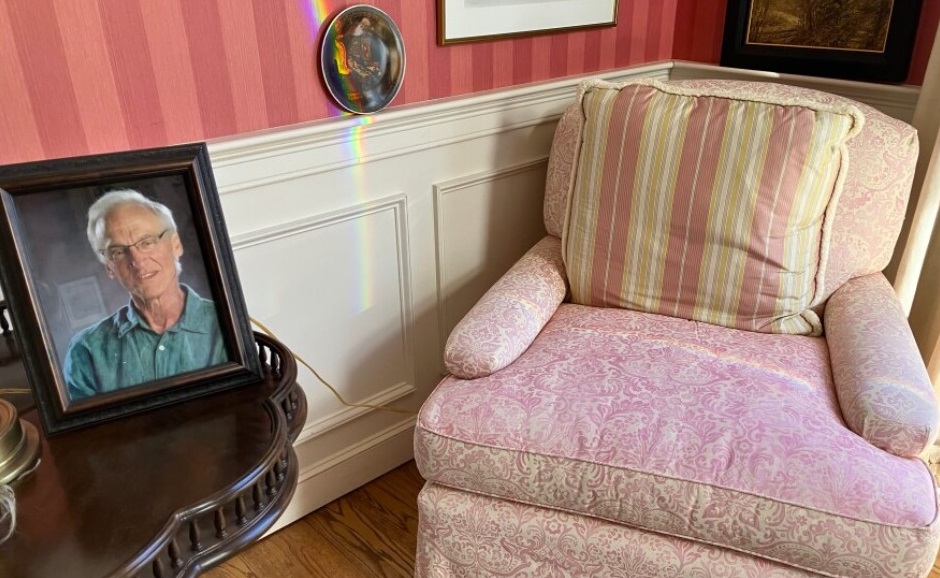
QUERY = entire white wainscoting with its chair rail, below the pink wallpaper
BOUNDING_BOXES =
[209,61,919,527]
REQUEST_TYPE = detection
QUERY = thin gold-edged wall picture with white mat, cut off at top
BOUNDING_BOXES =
[437,0,617,45]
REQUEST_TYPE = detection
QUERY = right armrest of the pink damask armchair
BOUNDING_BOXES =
[825,273,940,457]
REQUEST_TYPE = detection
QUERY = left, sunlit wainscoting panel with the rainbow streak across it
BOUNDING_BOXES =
[232,195,415,432]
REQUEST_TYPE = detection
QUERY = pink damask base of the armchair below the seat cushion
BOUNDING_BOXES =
[415,483,835,578]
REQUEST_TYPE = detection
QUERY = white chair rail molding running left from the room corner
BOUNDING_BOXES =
[209,62,672,194]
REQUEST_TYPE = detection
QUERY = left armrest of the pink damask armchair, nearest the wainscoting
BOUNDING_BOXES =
[444,236,568,379]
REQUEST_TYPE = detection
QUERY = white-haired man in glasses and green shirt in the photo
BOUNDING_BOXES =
[65,189,228,401]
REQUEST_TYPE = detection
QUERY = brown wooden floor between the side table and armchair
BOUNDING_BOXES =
[211,461,940,578]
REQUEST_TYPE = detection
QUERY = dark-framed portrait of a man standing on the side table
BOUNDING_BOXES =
[0,143,262,435]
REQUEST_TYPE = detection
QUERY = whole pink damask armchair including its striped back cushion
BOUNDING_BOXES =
[415,81,940,578]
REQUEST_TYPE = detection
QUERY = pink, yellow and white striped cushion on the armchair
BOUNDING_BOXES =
[563,80,863,334]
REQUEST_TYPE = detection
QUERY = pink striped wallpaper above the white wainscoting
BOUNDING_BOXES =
[0,0,940,164]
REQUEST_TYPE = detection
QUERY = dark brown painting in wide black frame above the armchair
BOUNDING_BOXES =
[721,0,921,83]
